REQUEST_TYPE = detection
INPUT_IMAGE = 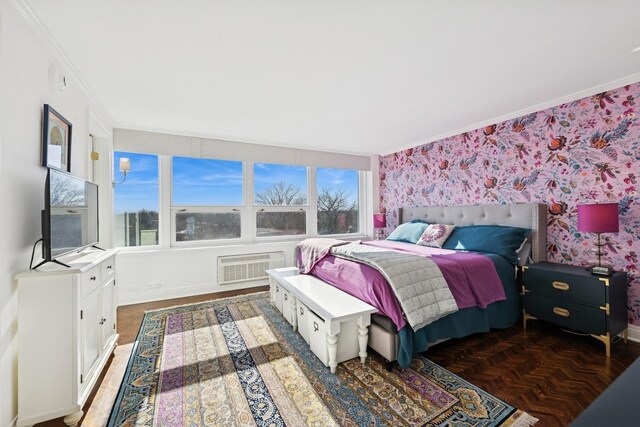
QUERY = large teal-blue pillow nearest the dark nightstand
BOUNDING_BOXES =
[442,225,531,265]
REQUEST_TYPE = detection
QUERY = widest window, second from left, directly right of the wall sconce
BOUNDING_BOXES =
[171,157,243,242]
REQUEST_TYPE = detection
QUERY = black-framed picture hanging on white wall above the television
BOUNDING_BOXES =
[42,104,72,172]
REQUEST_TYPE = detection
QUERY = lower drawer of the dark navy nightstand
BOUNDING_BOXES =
[524,293,607,335]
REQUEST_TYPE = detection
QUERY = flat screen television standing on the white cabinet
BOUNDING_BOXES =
[36,169,99,268]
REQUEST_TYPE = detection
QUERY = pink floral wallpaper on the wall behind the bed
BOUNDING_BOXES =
[380,83,640,324]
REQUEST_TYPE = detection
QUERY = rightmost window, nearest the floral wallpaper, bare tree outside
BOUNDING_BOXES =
[316,168,360,235]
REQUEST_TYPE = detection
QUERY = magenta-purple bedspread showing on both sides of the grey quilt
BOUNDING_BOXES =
[310,240,506,330]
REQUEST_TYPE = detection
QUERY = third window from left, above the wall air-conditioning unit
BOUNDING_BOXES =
[253,163,309,237]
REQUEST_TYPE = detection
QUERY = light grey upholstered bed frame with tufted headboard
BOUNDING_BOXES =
[369,203,547,362]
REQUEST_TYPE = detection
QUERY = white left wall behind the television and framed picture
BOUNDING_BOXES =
[0,0,108,426]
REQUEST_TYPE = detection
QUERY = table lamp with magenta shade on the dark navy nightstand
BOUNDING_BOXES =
[578,203,619,276]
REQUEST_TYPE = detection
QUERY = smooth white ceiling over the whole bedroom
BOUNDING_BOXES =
[25,0,640,154]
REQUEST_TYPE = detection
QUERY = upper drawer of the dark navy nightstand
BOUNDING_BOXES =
[522,268,606,306]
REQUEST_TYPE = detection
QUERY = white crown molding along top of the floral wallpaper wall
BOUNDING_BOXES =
[380,73,640,156]
